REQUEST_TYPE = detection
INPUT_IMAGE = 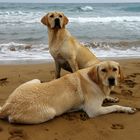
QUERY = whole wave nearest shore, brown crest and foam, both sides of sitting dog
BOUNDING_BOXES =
[0,41,140,61]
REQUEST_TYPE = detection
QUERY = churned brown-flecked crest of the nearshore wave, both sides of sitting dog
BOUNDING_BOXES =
[0,40,140,51]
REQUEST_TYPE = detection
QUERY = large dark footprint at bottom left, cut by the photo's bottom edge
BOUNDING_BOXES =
[8,128,27,140]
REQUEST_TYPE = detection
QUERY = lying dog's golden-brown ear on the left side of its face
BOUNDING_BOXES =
[88,66,99,84]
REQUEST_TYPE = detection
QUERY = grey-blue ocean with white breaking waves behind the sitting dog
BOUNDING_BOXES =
[0,3,140,63]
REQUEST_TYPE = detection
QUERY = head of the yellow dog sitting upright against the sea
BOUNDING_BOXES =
[41,12,69,29]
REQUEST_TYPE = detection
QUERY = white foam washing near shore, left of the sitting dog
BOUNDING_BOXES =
[0,42,52,61]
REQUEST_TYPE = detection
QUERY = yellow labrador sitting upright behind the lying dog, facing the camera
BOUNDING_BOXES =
[41,12,99,78]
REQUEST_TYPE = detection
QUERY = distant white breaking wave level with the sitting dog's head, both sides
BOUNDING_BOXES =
[0,16,140,24]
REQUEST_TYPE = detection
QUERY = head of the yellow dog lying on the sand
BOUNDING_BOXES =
[88,61,123,87]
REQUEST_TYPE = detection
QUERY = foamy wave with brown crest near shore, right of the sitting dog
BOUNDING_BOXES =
[84,41,140,58]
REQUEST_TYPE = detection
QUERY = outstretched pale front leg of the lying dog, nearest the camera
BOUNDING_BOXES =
[87,105,136,118]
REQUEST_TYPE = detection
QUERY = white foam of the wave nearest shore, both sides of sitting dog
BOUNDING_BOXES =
[0,42,140,63]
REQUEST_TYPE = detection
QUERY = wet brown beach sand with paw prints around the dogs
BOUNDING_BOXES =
[0,59,140,140]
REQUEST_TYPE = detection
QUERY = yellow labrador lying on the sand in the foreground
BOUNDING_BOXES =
[0,61,136,124]
